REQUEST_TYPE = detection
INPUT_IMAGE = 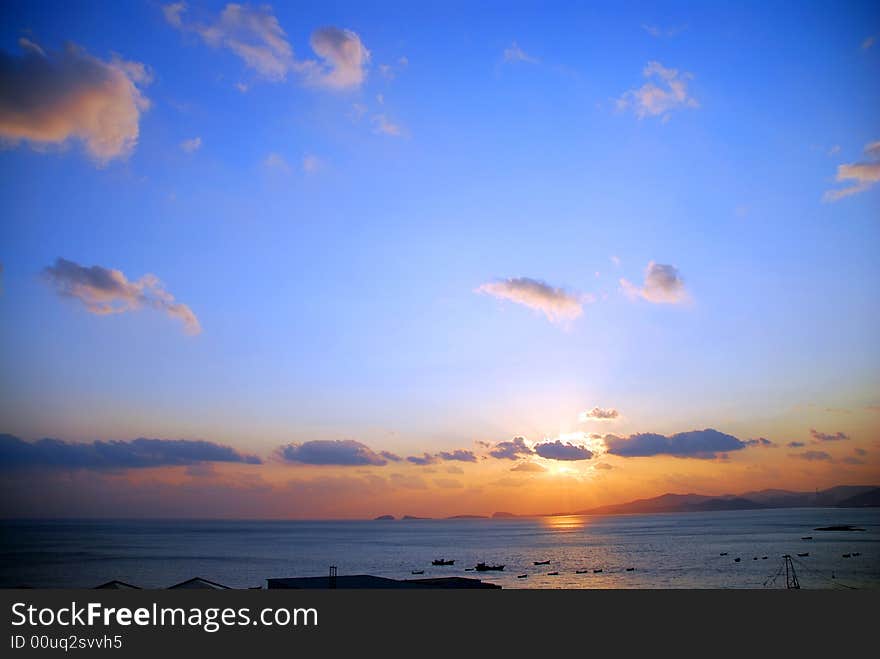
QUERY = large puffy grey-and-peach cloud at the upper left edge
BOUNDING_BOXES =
[0,38,151,164]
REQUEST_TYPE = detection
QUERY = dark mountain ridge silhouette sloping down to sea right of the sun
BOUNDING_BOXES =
[572,485,880,515]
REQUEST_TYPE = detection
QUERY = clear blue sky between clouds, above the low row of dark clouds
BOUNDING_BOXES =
[0,2,880,516]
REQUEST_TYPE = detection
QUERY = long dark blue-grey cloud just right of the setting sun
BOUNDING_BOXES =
[605,428,746,460]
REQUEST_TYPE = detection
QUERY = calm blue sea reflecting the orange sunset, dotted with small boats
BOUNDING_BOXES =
[0,508,880,589]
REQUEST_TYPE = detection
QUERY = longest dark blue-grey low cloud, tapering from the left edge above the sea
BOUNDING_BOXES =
[0,435,261,469]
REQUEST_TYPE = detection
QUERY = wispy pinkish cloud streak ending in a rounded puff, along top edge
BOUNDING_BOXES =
[162,2,370,89]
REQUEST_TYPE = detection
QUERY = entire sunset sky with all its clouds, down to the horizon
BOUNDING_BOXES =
[0,0,880,518]
